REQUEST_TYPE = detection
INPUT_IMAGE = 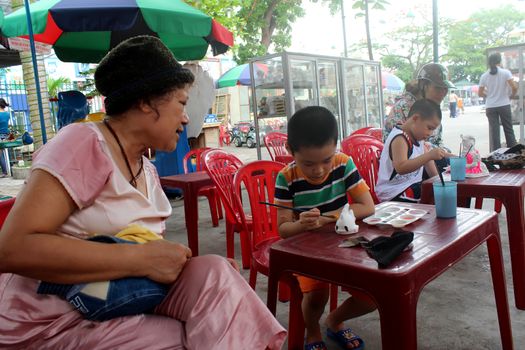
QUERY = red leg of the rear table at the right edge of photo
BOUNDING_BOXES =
[502,191,525,310]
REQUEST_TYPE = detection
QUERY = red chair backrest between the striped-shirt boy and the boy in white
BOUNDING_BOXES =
[341,135,383,204]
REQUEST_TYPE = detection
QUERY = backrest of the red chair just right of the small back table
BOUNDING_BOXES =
[204,149,242,223]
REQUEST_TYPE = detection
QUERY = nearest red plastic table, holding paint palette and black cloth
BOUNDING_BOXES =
[268,202,513,350]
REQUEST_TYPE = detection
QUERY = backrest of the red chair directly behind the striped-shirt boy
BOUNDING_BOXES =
[233,160,284,251]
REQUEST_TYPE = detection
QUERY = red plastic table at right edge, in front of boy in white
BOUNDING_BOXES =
[421,169,525,310]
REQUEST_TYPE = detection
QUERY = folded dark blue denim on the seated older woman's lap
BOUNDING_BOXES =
[37,236,169,321]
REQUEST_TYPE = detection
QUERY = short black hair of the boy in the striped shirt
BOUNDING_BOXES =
[288,106,338,153]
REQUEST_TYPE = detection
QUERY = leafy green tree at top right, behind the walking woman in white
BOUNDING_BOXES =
[444,5,525,83]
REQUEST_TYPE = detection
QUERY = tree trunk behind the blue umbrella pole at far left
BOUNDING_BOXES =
[11,0,55,151]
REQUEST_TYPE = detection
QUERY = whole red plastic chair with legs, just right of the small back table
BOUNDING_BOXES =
[204,149,251,269]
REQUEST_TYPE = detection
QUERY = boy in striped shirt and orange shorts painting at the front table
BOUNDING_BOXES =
[275,106,375,350]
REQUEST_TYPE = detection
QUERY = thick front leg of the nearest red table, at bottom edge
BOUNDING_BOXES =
[374,286,420,350]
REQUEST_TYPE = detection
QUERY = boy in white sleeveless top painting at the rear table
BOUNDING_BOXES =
[375,99,454,202]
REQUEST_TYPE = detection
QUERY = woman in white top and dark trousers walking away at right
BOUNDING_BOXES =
[478,52,518,152]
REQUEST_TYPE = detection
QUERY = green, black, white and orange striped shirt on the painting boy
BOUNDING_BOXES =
[275,153,370,213]
